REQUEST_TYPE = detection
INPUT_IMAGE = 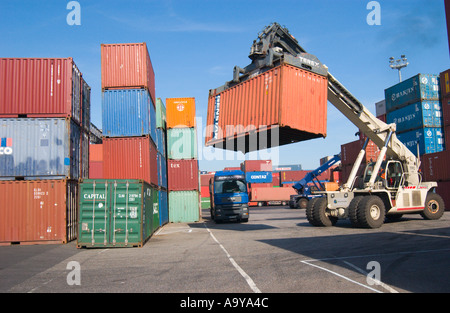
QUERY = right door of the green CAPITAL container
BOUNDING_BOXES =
[109,181,143,246]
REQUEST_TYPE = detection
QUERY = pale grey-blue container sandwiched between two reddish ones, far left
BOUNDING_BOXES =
[0,118,82,180]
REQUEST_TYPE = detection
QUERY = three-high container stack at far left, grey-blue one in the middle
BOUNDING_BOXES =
[0,58,90,244]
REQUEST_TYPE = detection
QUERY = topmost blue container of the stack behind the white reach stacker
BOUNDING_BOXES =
[384,74,440,112]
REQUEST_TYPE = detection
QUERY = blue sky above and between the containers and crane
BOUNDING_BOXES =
[0,0,450,170]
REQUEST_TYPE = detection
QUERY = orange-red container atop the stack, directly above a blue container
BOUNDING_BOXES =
[101,42,156,105]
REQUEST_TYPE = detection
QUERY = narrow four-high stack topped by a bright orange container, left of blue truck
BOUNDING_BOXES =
[166,98,200,222]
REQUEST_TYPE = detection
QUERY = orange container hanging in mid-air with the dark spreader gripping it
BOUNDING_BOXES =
[205,23,327,153]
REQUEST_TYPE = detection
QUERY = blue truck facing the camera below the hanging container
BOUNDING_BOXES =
[209,170,249,223]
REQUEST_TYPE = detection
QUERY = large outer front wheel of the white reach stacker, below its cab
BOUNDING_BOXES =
[357,196,386,228]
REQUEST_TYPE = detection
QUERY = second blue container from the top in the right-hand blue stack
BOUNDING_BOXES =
[386,100,442,132]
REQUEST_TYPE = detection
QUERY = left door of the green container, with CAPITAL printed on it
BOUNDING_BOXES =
[78,181,111,246]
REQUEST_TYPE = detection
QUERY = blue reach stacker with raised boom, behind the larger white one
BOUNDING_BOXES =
[289,153,341,209]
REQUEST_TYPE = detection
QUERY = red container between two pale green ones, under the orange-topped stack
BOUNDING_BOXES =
[167,159,199,191]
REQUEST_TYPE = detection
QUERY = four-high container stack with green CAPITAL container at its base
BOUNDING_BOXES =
[78,43,160,247]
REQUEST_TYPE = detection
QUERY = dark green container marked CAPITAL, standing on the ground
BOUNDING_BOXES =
[77,179,159,248]
